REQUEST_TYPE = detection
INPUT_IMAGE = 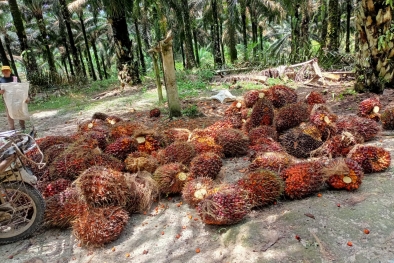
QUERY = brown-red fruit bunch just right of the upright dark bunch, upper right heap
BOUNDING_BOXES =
[274,103,309,132]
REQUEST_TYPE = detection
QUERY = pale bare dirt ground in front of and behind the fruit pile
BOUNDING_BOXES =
[0,75,394,263]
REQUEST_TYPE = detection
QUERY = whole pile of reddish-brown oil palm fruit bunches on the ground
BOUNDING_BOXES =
[24,85,394,246]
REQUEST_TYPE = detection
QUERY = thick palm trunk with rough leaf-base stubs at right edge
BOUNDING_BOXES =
[355,0,394,93]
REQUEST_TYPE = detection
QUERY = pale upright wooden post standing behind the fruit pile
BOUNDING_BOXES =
[160,33,182,118]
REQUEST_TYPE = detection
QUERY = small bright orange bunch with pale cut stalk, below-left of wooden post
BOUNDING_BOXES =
[134,130,165,154]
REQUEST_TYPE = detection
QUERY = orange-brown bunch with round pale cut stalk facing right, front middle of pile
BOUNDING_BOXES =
[153,163,189,194]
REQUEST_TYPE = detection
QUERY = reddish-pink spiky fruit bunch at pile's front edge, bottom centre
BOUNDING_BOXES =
[197,185,252,225]
